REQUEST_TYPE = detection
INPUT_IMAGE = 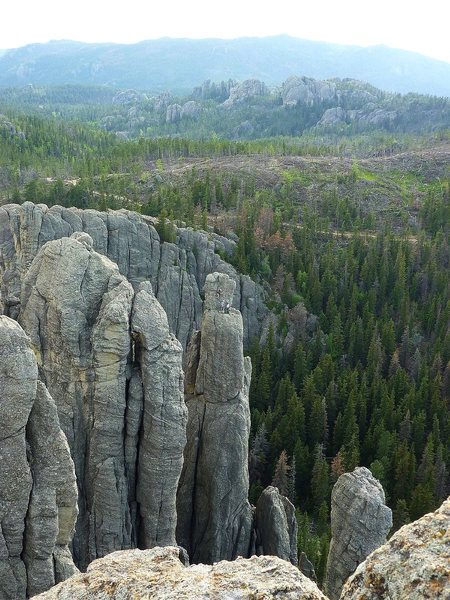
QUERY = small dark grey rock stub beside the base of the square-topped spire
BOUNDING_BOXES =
[255,486,298,566]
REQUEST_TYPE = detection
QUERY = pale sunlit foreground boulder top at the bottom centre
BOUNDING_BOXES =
[32,547,326,600]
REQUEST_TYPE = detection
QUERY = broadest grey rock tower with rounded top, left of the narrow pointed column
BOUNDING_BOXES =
[19,233,134,568]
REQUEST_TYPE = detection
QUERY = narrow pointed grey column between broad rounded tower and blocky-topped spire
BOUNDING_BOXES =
[131,282,187,548]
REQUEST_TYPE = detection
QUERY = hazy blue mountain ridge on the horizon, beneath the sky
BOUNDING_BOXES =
[0,35,450,96]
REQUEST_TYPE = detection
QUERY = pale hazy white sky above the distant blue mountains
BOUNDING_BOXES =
[0,0,450,62]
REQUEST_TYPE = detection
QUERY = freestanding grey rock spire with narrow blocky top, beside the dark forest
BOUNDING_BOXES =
[177,273,252,563]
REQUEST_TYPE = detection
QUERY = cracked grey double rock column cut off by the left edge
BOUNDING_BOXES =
[0,316,77,600]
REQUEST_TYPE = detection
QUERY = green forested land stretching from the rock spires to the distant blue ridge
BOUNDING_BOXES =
[0,82,450,579]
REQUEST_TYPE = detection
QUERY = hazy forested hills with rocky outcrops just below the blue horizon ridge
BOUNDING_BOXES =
[0,76,450,145]
